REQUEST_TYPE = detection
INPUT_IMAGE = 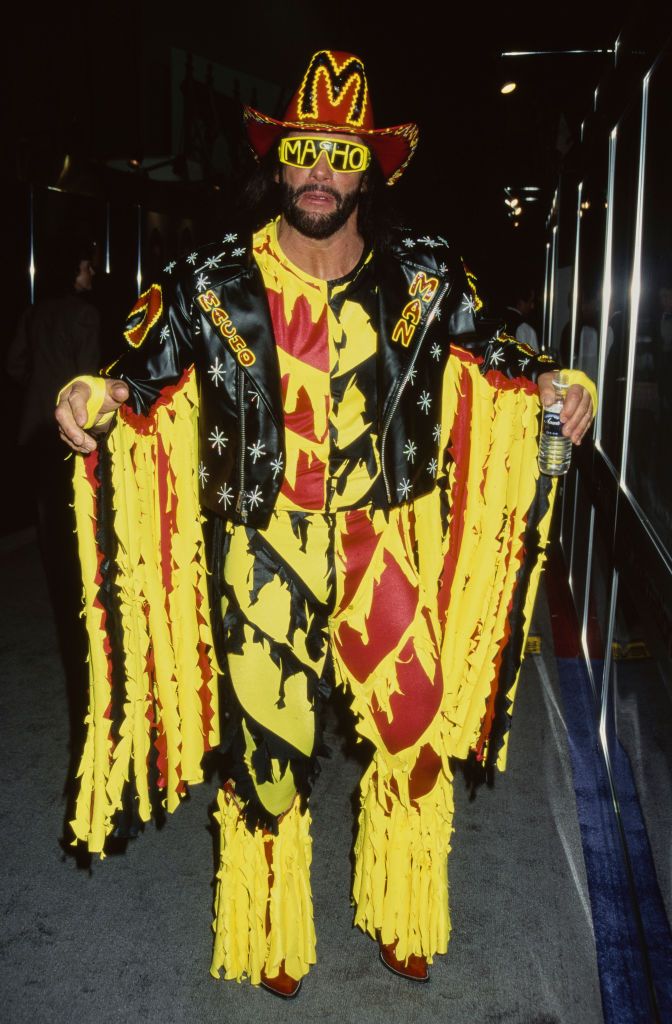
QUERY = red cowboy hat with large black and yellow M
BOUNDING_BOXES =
[243,50,418,185]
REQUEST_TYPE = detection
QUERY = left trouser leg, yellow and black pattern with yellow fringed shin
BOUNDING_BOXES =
[211,515,328,984]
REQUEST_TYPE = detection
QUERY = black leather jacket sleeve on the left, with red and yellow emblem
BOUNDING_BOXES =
[104,274,194,416]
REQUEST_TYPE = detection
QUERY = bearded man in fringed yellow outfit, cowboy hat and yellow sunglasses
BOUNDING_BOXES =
[56,50,591,996]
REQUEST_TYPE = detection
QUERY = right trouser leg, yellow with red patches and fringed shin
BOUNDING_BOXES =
[331,510,453,961]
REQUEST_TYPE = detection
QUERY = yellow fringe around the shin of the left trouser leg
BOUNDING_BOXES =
[210,791,316,985]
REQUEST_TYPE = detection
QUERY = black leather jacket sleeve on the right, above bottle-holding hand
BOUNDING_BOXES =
[450,261,559,384]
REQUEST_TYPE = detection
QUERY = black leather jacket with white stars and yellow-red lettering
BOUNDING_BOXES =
[109,224,555,527]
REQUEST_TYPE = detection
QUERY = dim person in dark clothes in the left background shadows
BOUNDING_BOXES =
[7,234,100,757]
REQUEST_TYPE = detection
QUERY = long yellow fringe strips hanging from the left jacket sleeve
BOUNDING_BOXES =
[72,376,219,853]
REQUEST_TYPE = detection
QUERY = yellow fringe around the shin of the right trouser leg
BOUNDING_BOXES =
[352,760,453,964]
